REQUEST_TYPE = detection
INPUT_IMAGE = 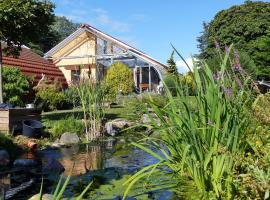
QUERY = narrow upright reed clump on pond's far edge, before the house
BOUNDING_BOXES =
[77,79,104,141]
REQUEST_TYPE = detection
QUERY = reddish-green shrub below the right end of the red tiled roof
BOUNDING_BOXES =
[35,81,66,111]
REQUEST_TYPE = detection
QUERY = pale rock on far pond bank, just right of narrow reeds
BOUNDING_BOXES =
[105,119,133,136]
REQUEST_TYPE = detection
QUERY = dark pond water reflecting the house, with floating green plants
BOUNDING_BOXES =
[0,134,173,200]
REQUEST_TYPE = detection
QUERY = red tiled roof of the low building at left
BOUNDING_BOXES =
[2,44,67,88]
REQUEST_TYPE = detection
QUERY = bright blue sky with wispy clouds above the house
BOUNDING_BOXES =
[53,0,249,72]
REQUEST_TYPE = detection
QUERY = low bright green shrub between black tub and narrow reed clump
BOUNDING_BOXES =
[49,116,84,139]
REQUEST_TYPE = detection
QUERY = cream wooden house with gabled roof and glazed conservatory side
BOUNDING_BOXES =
[45,24,166,92]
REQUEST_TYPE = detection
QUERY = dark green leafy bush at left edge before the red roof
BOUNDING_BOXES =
[3,67,30,106]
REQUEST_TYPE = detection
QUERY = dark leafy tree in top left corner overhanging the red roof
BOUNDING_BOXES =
[0,0,54,103]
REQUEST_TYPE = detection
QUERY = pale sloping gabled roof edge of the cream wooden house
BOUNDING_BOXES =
[45,24,167,71]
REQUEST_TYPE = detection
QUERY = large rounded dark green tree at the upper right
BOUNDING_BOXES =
[198,1,270,79]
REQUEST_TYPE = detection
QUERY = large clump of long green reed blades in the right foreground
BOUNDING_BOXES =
[124,47,253,199]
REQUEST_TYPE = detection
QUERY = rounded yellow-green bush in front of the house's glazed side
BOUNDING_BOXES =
[104,62,134,101]
